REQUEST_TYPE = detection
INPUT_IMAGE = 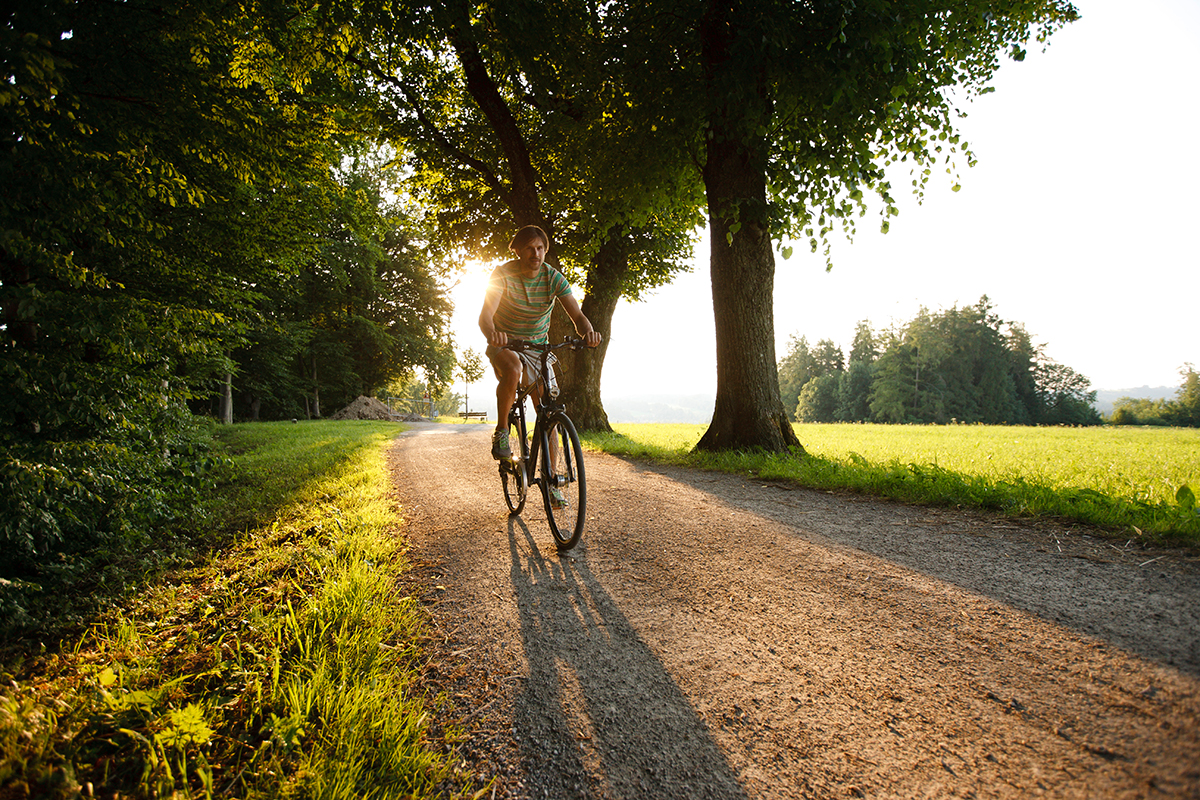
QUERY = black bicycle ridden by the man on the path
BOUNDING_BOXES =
[500,337,588,551]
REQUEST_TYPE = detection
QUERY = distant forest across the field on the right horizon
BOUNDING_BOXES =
[779,295,1200,427]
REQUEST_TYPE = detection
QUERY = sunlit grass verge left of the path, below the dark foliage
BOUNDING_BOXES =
[0,422,466,798]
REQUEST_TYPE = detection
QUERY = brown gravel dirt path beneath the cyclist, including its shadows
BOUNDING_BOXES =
[391,425,1200,799]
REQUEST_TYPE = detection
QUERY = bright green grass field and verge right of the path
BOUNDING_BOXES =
[588,425,1200,548]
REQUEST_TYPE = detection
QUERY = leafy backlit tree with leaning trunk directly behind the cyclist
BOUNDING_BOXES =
[361,0,696,429]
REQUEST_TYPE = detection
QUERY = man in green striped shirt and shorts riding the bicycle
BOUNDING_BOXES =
[479,225,601,494]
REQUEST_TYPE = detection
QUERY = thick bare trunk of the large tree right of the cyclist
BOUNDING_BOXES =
[696,0,800,452]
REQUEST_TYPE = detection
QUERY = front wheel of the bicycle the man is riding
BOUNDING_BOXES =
[541,415,588,551]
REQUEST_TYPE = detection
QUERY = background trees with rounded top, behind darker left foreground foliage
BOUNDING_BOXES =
[208,154,454,420]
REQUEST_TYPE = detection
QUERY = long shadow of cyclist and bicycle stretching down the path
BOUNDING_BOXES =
[509,515,746,799]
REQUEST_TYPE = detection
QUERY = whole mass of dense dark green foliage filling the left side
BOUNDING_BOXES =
[0,0,449,614]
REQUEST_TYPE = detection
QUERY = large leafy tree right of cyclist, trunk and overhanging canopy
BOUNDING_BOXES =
[631,0,1076,451]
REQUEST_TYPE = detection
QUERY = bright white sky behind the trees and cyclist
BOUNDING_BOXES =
[452,0,1200,399]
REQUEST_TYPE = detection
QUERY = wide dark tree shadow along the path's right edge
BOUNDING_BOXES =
[619,458,1200,676]
